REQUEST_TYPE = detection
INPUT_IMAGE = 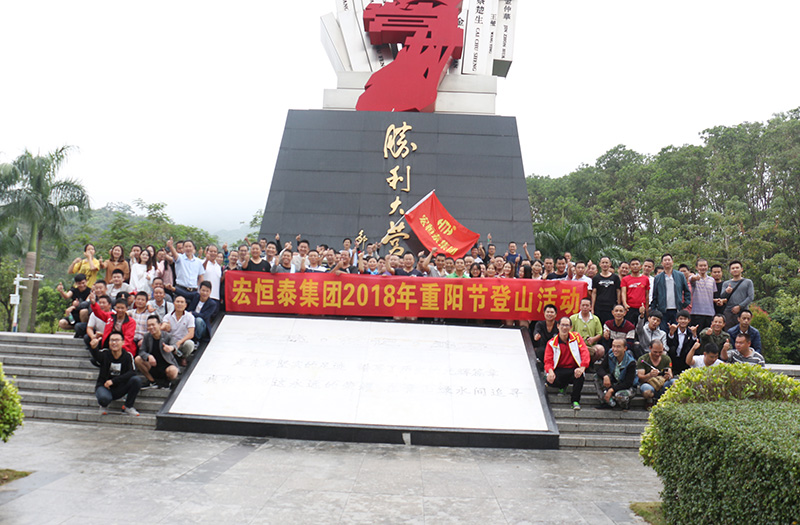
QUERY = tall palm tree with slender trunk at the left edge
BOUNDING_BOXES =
[0,146,89,332]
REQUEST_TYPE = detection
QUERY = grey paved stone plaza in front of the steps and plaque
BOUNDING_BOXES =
[0,421,661,525]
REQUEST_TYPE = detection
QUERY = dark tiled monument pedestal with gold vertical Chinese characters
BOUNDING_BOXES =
[260,110,533,255]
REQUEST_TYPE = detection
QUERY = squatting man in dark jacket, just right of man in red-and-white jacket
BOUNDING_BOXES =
[595,337,639,410]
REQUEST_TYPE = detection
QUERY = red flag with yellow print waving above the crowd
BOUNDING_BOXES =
[405,190,481,259]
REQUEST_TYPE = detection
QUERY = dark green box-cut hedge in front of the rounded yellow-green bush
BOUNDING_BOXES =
[650,400,800,525]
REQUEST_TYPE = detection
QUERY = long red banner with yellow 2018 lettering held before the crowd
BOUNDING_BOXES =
[225,272,587,320]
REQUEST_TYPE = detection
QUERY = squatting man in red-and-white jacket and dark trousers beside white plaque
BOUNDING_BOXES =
[544,317,590,410]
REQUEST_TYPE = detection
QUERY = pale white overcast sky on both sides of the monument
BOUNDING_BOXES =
[0,0,800,232]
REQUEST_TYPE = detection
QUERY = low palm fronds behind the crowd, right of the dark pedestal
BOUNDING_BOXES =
[534,217,621,262]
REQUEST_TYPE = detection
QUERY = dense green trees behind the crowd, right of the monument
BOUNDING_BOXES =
[528,108,800,362]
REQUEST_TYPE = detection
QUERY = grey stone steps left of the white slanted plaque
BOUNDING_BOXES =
[0,332,170,428]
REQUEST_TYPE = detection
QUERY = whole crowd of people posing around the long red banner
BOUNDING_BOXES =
[53,235,764,415]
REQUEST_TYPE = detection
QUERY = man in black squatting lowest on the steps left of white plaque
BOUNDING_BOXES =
[95,332,142,416]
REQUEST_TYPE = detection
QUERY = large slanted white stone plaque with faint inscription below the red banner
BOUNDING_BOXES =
[169,315,547,431]
